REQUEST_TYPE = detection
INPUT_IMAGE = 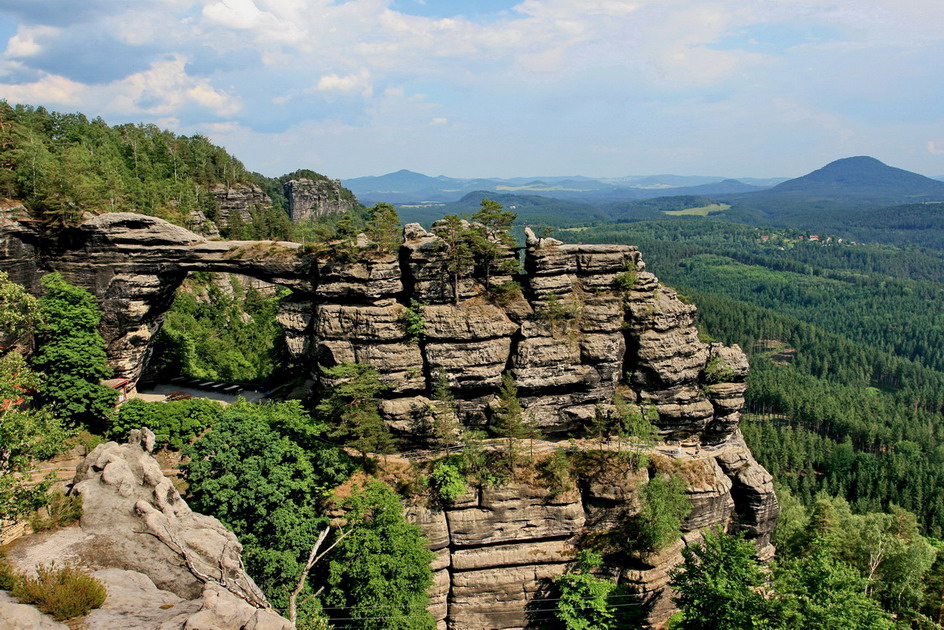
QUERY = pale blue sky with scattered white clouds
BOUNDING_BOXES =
[0,0,944,178]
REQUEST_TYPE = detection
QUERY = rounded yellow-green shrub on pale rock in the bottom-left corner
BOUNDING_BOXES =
[13,564,108,621]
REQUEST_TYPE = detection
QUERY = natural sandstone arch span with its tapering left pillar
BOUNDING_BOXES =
[0,213,313,379]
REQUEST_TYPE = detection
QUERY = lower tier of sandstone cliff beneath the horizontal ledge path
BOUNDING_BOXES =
[408,443,776,630]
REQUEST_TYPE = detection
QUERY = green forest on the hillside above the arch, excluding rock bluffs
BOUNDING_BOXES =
[0,102,259,223]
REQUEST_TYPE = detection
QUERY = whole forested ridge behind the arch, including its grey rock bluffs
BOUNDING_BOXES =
[0,101,358,239]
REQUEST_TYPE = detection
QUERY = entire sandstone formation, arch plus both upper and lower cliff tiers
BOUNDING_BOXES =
[0,214,778,630]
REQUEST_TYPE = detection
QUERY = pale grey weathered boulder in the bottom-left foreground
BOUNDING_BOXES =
[0,429,292,630]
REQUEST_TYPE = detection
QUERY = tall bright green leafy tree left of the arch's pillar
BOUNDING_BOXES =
[32,273,116,426]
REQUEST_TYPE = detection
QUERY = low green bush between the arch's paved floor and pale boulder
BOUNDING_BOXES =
[109,398,223,450]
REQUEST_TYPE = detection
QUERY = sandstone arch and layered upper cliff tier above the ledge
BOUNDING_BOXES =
[0,213,747,444]
